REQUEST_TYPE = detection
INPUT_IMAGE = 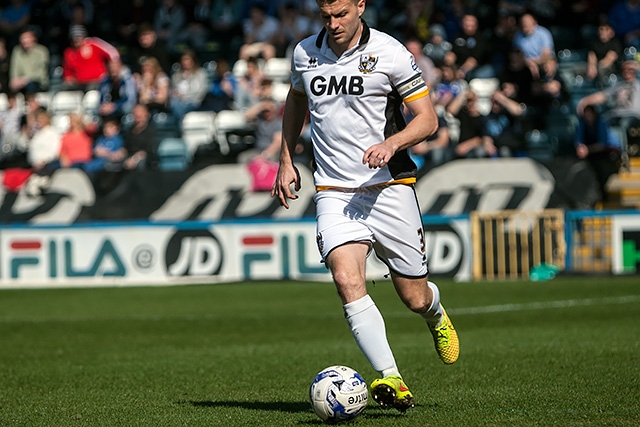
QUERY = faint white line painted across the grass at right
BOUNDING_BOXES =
[447,295,640,315]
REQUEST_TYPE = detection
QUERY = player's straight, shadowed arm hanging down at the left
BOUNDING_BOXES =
[271,89,309,209]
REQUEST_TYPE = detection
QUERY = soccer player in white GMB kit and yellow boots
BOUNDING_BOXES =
[271,0,459,411]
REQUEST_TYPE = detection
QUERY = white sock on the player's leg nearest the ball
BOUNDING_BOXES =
[344,295,400,377]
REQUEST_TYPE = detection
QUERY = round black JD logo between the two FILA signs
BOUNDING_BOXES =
[165,230,223,277]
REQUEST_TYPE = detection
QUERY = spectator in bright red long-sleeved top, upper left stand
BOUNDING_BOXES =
[62,25,120,90]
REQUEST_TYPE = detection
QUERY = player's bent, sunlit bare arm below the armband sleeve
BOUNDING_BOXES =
[362,91,438,168]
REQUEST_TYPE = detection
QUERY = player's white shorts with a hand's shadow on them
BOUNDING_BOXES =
[314,184,428,278]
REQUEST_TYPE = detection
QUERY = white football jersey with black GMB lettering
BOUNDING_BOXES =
[291,21,429,189]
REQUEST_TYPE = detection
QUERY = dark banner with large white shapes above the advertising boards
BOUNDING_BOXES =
[0,158,597,225]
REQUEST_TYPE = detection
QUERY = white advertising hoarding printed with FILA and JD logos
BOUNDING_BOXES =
[0,218,471,288]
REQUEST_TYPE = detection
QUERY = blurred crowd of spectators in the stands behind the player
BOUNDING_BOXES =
[0,0,640,202]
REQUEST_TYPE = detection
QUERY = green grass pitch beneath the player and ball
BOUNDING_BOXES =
[0,276,640,427]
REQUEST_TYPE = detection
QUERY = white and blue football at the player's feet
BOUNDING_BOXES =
[309,365,369,424]
